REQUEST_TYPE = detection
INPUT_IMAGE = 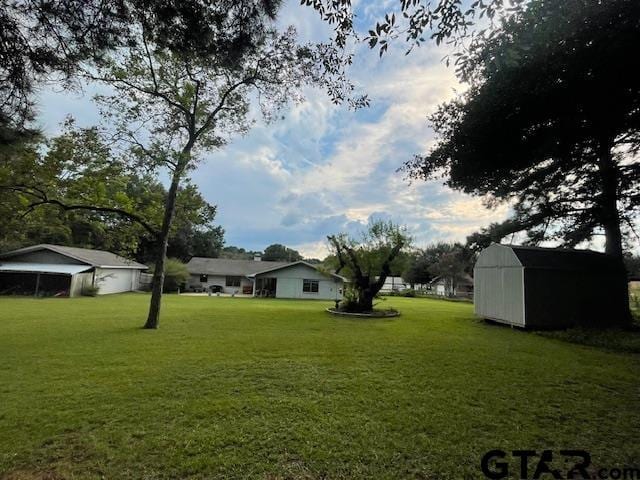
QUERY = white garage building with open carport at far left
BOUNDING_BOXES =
[0,244,147,297]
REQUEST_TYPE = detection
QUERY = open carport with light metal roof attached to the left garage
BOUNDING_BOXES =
[0,262,93,297]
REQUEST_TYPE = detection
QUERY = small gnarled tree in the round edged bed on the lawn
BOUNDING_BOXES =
[327,221,411,312]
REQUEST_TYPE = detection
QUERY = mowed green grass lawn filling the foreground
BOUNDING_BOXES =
[0,294,640,480]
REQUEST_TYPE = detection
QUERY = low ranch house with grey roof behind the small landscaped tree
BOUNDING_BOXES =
[187,257,344,300]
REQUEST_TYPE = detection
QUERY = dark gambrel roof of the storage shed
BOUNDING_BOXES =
[505,245,621,271]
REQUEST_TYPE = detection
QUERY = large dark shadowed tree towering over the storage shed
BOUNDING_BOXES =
[405,0,640,322]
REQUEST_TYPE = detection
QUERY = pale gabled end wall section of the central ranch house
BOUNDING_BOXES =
[257,264,343,300]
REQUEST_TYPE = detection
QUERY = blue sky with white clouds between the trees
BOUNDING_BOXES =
[39,0,508,258]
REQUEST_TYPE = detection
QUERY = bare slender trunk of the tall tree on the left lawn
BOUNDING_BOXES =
[144,167,184,329]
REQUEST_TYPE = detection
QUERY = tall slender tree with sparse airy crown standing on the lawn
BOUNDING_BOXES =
[86,14,366,328]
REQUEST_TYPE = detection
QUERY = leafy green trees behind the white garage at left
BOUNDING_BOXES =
[0,125,224,263]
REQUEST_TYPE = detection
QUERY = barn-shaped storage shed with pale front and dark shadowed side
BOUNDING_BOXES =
[473,244,626,329]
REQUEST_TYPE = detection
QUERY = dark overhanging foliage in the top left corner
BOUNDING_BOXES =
[0,0,294,148]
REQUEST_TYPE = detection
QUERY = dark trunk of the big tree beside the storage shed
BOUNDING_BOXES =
[598,137,631,325]
